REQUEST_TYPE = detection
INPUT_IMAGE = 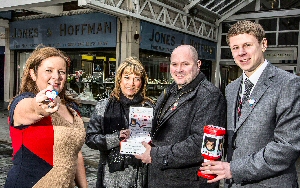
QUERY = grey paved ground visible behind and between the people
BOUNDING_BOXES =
[0,101,300,188]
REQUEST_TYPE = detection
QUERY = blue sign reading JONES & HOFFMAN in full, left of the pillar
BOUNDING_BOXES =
[9,13,117,50]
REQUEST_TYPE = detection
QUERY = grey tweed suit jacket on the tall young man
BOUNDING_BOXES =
[226,63,300,188]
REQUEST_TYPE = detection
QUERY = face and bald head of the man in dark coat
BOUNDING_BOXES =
[170,45,201,88]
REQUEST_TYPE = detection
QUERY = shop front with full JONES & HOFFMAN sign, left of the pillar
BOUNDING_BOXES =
[10,13,117,117]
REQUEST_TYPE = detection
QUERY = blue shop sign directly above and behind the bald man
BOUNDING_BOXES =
[140,21,217,60]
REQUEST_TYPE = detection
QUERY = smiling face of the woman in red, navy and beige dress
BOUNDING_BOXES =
[30,56,67,93]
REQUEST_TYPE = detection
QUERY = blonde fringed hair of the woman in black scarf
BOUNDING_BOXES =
[111,56,148,100]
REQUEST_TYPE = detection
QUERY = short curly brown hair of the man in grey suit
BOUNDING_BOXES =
[226,20,265,45]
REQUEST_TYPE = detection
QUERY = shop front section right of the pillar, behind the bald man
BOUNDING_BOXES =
[139,21,217,100]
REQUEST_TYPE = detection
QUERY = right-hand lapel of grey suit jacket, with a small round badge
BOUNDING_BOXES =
[235,63,275,132]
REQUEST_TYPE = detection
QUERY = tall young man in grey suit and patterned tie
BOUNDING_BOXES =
[200,21,300,188]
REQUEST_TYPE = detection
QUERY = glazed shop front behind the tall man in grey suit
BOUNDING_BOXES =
[219,17,300,92]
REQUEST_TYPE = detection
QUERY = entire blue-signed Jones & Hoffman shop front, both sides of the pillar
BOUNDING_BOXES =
[10,13,216,117]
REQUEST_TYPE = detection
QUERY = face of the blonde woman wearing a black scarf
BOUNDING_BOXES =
[120,69,142,99]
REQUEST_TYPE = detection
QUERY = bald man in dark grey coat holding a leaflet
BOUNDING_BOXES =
[136,45,226,188]
